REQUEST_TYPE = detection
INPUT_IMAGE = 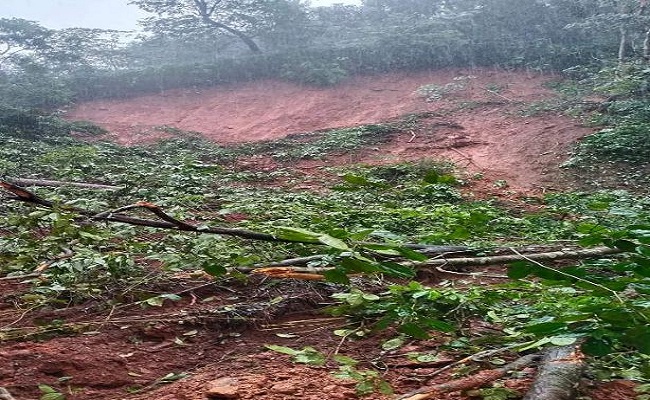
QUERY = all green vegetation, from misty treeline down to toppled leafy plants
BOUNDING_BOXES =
[0,0,650,398]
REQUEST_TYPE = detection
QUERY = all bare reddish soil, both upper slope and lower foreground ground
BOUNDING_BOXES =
[0,70,634,400]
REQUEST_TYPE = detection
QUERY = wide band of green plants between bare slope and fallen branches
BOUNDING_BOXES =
[0,119,640,310]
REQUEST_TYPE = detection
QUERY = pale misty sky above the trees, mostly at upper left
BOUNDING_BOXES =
[0,0,361,30]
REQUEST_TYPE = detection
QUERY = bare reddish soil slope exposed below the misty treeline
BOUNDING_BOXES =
[68,70,590,193]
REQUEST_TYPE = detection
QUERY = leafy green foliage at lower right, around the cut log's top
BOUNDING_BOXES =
[330,215,650,380]
